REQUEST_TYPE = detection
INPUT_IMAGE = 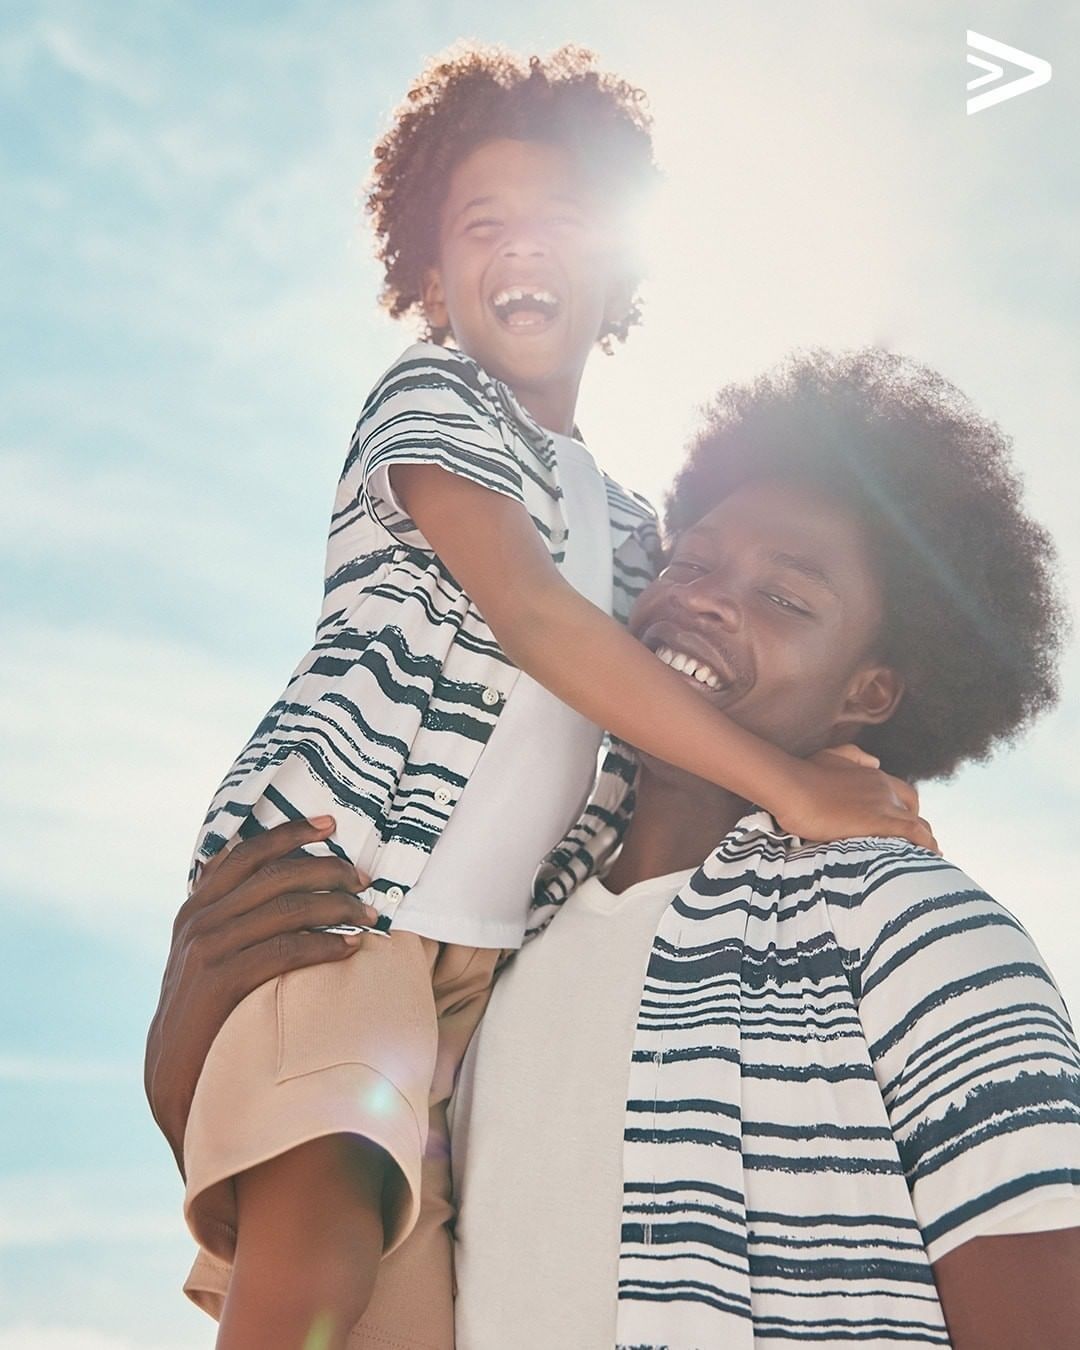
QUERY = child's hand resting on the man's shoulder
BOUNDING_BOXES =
[774,745,940,853]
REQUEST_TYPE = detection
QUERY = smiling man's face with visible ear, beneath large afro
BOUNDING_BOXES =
[630,481,902,756]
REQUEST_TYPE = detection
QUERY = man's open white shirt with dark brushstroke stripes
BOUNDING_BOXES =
[533,752,1080,1350]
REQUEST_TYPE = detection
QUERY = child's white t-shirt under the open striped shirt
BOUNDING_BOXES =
[394,433,612,948]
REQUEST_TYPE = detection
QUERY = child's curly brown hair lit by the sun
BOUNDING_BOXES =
[367,46,656,343]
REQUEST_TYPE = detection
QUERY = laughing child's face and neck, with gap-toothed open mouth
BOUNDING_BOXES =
[424,140,629,431]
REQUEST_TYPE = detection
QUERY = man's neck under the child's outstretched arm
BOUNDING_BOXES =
[605,764,747,892]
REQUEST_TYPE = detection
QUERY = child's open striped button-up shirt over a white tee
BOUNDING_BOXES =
[196,343,659,923]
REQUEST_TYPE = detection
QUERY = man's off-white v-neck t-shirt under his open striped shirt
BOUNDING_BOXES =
[452,872,1080,1350]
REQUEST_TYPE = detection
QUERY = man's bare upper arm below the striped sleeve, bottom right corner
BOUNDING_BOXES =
[933,1229,1080,1350]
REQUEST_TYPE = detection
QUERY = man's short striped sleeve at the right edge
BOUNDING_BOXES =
[855,845,1080,1261]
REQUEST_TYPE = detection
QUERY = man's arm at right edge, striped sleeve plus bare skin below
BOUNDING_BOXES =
[834,844,1080,1350]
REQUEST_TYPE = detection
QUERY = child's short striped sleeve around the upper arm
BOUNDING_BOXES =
[339,343,525,549]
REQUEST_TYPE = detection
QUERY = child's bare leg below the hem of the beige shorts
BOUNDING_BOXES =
[217,1134,393,1350]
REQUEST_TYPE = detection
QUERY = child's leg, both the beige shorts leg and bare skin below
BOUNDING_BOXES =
[185,933,439,1350]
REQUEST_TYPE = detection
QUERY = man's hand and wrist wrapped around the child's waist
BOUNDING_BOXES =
[144,817,377,1173]
